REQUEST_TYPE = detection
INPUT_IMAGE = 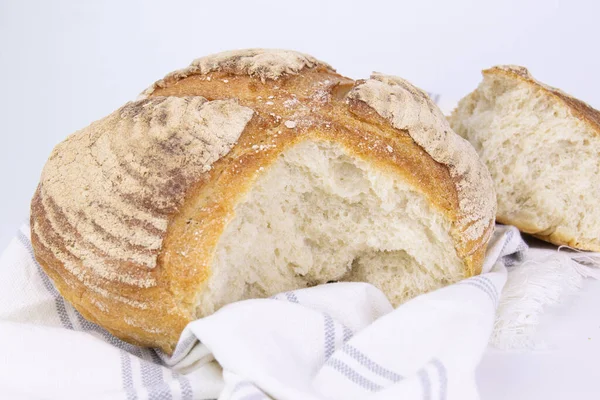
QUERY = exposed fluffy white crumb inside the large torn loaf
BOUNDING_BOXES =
[196,140,465,315]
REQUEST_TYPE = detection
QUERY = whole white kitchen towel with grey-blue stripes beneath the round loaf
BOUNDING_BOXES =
[0,226,591,399]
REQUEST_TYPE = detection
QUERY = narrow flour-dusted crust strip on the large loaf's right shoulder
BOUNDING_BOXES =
[348,73,496,245]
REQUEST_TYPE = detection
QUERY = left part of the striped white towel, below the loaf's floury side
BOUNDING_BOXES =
[0,226,223,400]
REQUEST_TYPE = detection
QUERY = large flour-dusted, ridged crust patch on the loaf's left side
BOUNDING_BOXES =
[32,96,254,290]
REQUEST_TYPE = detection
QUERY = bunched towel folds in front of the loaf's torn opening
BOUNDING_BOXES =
[177,263,506,400]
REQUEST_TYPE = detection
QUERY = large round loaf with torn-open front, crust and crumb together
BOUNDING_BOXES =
[31,50,496,352]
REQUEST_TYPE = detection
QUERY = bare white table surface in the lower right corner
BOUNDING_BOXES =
[477,280,600,400]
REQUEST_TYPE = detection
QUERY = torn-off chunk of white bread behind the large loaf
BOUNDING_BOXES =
[449,66,600,251]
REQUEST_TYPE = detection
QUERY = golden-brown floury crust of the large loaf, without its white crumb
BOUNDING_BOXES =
[31,50,495,352]
